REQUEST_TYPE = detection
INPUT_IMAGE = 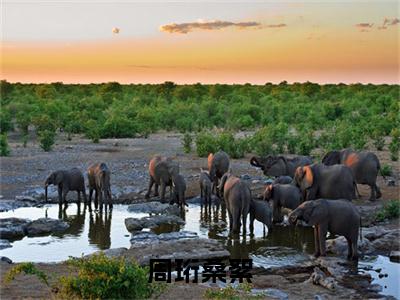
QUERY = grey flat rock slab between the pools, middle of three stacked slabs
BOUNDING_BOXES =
[125,215,185,232]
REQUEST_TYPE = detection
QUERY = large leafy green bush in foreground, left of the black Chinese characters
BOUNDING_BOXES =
[59,253,155,299]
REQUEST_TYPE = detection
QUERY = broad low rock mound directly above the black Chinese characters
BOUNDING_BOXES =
[127,238,230,266]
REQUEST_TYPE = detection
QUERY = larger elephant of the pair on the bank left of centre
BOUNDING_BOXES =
[145,155,179,202]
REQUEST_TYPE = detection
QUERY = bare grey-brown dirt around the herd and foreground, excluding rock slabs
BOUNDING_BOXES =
[0,133,400,299]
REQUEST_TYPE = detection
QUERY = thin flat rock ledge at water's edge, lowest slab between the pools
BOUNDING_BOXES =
[131,231,199,247]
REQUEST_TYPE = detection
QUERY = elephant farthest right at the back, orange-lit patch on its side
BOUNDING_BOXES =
[322,149,382,201]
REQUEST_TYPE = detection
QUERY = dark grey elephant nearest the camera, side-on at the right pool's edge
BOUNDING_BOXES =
[289,199,362,260]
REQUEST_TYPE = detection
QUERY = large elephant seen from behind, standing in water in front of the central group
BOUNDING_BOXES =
[218,173,252,235]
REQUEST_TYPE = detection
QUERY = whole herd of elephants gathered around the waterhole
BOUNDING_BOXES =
[45,149,381,259]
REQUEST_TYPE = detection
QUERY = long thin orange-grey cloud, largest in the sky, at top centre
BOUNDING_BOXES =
[160,20,261,34]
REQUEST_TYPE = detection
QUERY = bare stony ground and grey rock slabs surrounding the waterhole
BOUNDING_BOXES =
[0,134,399,299]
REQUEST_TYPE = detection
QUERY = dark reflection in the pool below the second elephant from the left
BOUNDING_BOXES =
[89,209,112,250]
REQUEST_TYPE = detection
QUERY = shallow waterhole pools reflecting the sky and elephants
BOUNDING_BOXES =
[0,204,399,297]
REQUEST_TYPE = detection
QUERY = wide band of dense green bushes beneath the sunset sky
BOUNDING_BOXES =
[0,81,400,160]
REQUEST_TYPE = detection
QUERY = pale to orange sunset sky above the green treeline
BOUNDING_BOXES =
[0,0,400,84]
